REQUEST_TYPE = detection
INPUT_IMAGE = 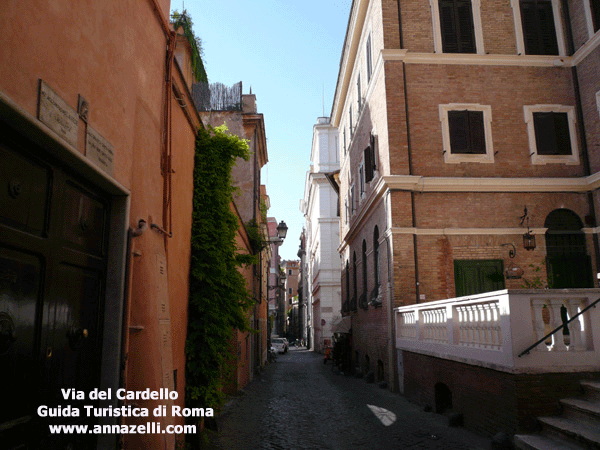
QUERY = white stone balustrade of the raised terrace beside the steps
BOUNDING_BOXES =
[395,289,600,373]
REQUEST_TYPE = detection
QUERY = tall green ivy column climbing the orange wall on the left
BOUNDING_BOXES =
[186,125,254,408]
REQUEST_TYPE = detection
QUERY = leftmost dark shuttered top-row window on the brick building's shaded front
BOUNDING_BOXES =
[439,0,476,53]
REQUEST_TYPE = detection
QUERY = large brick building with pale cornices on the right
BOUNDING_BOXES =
[331,0,600,398]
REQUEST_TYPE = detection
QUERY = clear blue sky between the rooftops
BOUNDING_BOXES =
[171,0,352,259]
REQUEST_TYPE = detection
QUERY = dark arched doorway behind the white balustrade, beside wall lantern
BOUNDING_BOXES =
[544,209,594,289]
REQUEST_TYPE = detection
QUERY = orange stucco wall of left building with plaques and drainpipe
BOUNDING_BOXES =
[0,0,202,449]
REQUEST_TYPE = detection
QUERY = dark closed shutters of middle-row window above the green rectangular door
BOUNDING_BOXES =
[448,111,486,154]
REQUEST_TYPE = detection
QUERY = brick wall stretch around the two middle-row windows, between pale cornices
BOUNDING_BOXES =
[406,64,583,177]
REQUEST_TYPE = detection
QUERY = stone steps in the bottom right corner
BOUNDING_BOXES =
[515,381,600,450]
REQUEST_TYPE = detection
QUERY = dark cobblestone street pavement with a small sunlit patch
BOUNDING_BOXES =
[210,348,490,450]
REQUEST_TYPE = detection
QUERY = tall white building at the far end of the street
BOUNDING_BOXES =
[300,117,342,352]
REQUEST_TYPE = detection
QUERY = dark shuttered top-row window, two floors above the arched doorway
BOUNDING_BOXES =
[521,0,558,55]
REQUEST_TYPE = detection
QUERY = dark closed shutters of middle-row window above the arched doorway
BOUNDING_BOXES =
[533,112,572,155]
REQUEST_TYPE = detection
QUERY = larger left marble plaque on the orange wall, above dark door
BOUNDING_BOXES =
[38,80,79,148]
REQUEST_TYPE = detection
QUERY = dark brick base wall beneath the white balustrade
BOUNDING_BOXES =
[402,351,600,436]
